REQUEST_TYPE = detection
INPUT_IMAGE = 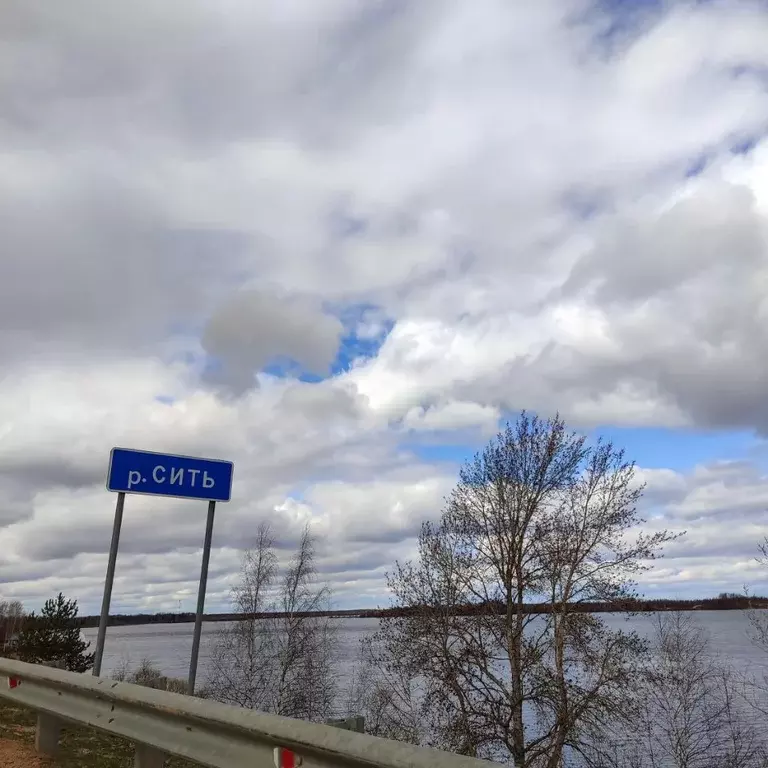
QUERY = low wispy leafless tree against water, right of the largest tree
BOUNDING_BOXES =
[593,613,765,768]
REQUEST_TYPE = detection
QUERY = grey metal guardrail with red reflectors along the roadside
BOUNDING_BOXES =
[0,658,488,768]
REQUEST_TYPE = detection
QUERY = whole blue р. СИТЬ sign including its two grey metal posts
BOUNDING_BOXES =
[98,448,234,695]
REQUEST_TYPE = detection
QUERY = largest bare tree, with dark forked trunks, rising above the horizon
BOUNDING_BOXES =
[366,413,673,768]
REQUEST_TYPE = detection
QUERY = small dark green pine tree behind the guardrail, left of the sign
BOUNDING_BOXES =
[12,592,94,672]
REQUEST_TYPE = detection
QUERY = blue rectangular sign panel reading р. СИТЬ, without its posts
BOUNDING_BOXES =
[107,448,234,501]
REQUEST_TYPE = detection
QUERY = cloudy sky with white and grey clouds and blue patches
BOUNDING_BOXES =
[0,0,768,613]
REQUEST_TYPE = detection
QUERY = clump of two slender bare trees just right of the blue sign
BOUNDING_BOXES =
[205,524,337,720]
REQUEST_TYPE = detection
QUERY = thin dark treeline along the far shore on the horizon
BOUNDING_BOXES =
[70,594,768,628]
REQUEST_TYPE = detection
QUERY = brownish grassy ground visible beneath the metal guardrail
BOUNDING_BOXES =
[0,699,195,768]
